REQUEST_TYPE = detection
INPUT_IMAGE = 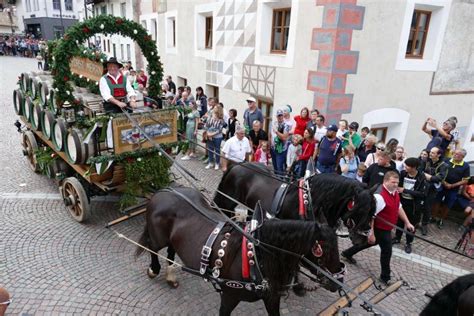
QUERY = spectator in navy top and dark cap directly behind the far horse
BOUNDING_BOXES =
[316,124,342,173]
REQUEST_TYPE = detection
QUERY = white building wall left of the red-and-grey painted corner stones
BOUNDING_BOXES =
[146,0,321,123]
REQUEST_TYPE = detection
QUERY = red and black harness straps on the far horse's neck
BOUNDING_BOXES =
[270,178,315,221]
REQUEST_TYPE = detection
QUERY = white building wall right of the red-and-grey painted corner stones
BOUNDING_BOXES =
[343,0,474,160]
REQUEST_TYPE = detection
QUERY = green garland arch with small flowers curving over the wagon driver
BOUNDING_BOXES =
[48,15,163,104]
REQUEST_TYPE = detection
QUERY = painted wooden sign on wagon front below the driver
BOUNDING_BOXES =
[112,110,178,154]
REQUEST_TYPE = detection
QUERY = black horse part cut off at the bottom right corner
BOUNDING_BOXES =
[420,273,474,316]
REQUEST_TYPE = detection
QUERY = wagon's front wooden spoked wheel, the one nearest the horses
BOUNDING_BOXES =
[61,177,90,223]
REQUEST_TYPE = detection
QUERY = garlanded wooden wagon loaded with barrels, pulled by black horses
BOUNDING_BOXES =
[13,17,177,222]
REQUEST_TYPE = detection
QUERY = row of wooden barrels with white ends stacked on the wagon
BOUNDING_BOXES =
[13,71,101,169]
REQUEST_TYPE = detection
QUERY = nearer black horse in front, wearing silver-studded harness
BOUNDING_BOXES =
[137,188,341,315]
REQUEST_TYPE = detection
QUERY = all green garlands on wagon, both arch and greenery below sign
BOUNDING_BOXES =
[48,15,175,209]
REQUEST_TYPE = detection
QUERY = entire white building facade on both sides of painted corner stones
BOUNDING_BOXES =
[140,0,474,160]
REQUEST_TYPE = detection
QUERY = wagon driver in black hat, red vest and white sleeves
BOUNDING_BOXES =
[99,57,137,113]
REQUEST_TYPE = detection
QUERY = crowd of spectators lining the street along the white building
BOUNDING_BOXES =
[153,81,474,253]
